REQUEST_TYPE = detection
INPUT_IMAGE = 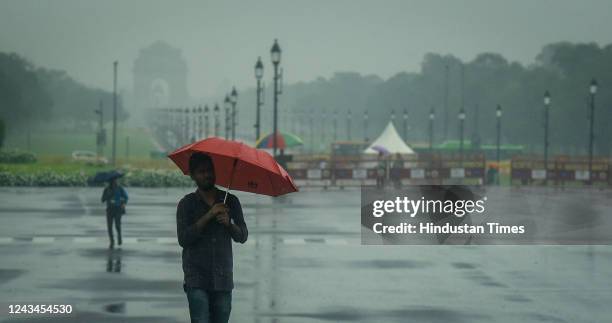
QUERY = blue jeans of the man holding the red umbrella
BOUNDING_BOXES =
[183,285,232,323]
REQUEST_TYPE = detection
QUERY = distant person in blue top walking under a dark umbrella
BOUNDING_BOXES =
[102,177,128,249]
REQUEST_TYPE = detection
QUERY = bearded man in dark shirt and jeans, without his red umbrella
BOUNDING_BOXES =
[176,152,248,323]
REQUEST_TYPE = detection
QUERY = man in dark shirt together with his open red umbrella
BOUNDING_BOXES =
[168,137,297,322]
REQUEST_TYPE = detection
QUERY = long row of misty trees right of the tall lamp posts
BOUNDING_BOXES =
[239,42,612,155]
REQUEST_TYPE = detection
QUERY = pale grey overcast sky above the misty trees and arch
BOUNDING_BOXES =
[0,0,612,97]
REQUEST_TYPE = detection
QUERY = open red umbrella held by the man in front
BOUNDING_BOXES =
[168,137,298,198]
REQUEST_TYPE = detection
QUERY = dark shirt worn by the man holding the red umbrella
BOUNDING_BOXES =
[176,189,248,290]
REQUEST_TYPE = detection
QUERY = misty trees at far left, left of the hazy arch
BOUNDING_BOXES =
[0,53,128,136]
